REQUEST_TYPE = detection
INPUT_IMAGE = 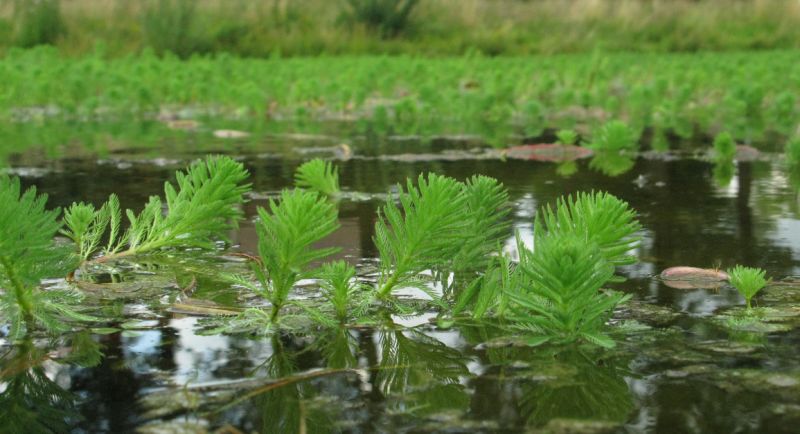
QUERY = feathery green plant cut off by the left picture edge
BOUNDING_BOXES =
[0,176,91,339]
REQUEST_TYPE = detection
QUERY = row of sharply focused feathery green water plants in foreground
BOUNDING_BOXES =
[0,156,766,348]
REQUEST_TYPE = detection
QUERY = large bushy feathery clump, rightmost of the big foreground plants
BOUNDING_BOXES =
[504,192,640,347]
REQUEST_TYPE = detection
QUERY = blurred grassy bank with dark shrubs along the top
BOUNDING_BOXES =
[0,0,800,57]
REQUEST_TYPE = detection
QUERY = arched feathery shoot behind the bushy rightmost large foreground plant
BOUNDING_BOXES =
[534,192,641,266]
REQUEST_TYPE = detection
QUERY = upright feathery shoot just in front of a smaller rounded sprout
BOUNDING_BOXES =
[254,190,339,322]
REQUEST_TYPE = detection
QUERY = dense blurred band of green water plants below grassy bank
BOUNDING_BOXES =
[0,47,800,149]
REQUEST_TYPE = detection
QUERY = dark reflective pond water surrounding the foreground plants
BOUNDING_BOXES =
[0,133,800,433]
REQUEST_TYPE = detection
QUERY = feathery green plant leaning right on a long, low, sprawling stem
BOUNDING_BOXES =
[63,156,250,261]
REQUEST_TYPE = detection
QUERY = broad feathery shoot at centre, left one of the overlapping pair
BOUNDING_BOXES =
[374,173,468,297]
